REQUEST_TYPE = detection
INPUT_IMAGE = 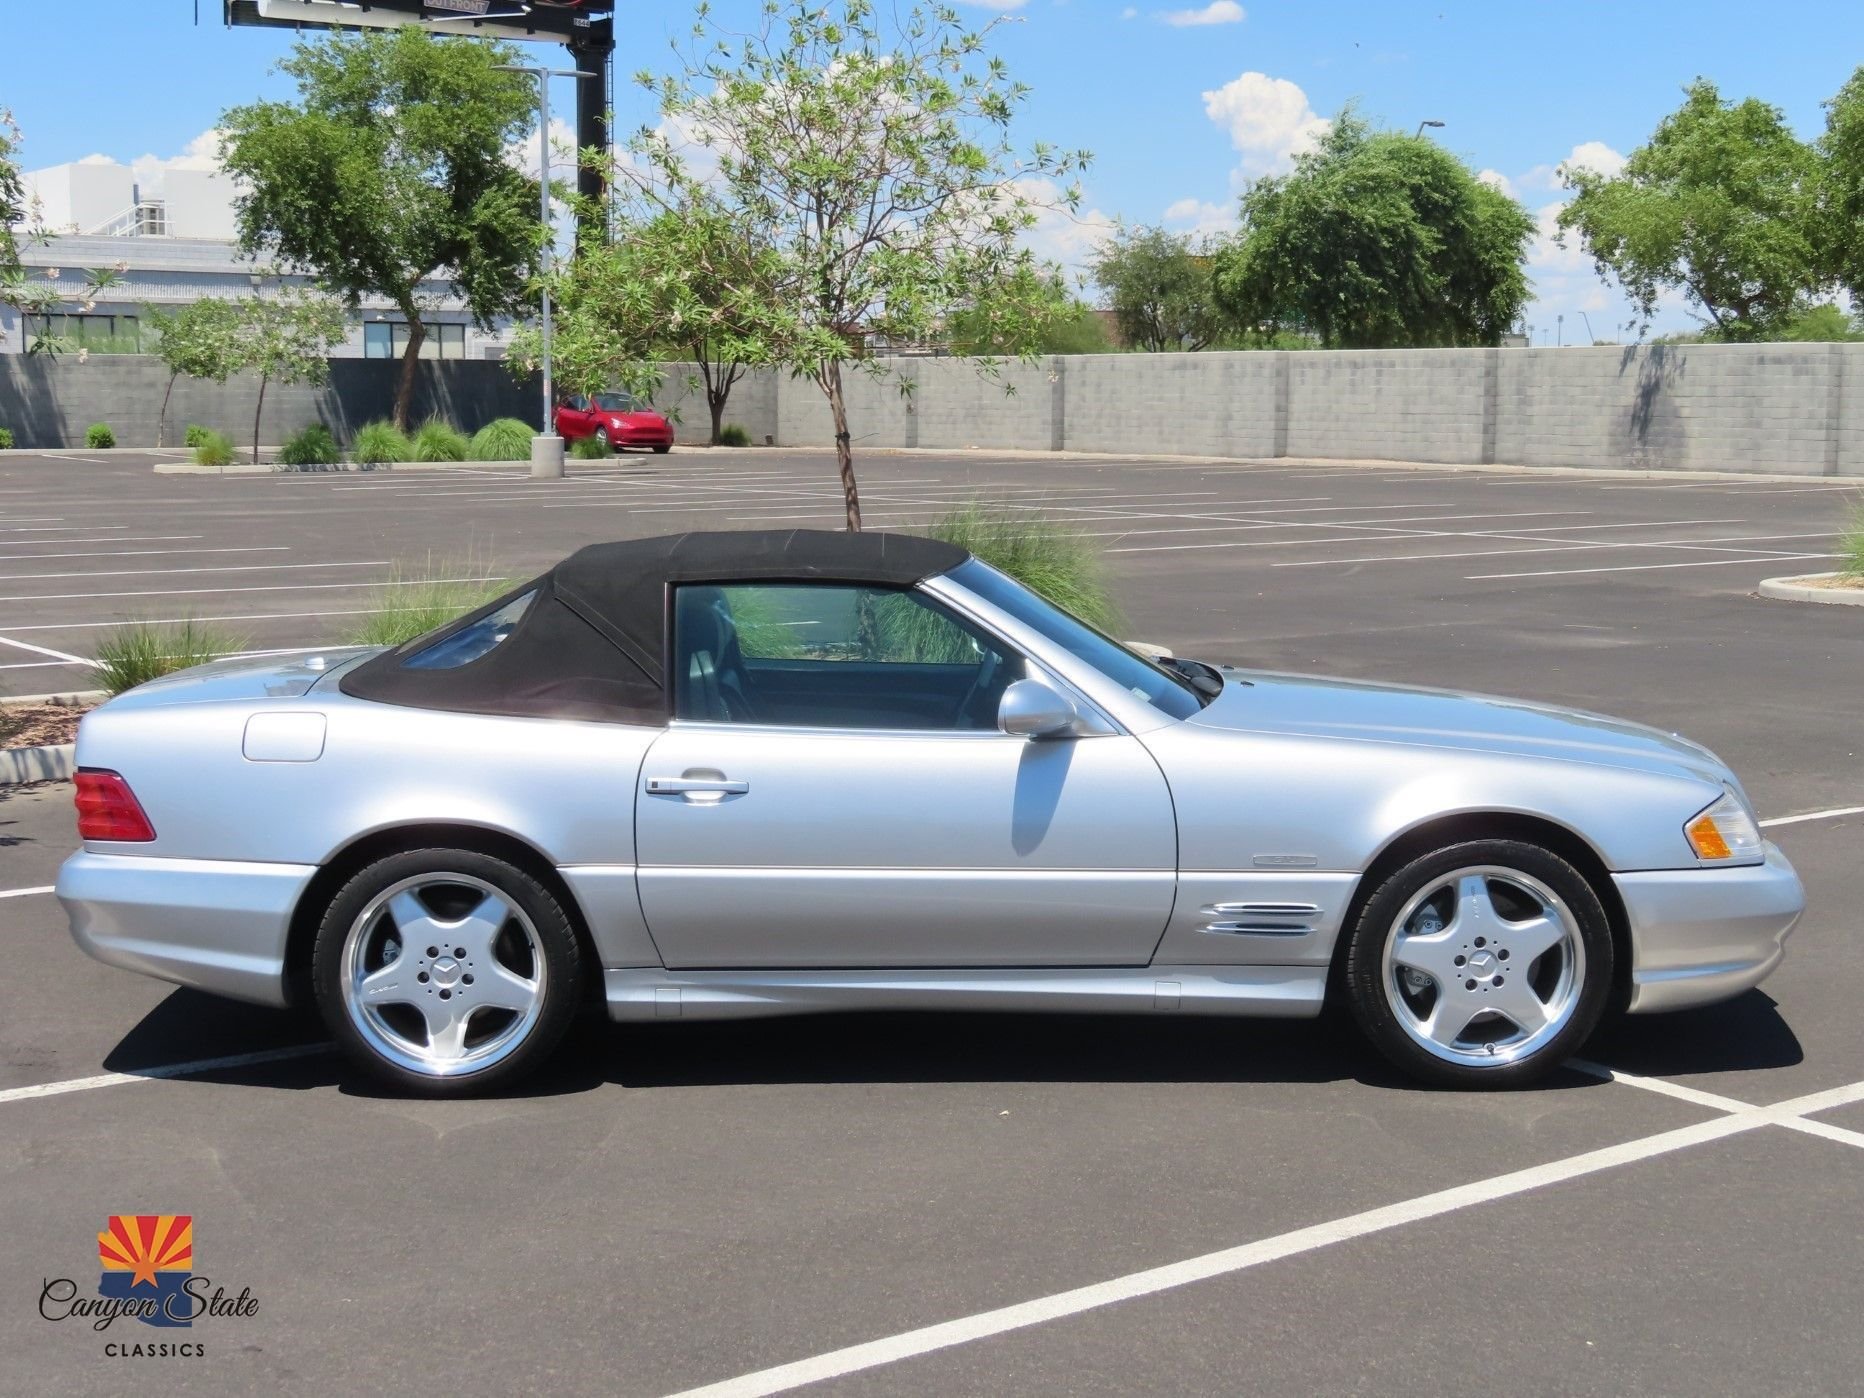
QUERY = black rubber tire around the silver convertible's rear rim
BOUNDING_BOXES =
[311,848,583,1098]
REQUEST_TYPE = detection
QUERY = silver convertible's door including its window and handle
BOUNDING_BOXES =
[636,583,1176,967]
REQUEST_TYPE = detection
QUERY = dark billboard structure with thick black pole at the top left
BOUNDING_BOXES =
[224,0,615,215]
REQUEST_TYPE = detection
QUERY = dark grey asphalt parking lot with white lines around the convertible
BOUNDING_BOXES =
[0,451,1864,1394]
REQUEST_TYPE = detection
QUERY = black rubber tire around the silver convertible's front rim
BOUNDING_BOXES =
[1340,841,1614,1089]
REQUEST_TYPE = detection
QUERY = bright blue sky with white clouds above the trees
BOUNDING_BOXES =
[0,0,1864,343]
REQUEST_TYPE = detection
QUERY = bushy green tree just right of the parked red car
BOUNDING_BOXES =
[507,198,774,445]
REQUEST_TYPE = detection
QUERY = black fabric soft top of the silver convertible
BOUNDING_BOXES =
[337,529,969,723]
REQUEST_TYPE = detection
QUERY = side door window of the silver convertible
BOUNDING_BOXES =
[673,583,1023,731]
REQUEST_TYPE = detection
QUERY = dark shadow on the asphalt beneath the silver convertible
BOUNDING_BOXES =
[104,990,1804,1098]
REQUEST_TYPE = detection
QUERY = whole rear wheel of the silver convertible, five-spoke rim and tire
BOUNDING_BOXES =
[311,850,582,1096]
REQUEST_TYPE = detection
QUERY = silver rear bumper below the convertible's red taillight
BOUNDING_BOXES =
[58,850,317,1005]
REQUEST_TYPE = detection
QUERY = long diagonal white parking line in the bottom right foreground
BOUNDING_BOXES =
[677,1083,1864,1398]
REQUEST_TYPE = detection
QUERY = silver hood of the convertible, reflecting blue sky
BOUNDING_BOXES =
[1189,671,1734,783]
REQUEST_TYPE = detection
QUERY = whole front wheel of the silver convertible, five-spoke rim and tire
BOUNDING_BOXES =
[1344,841,1612,1087]
